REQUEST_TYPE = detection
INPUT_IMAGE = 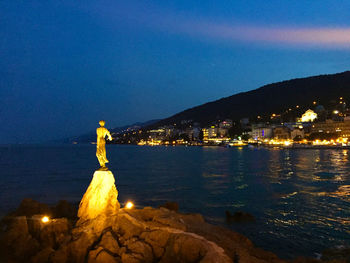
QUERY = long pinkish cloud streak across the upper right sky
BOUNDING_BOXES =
[179,22,350,48]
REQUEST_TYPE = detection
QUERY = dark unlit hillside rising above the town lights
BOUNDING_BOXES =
[152,71,350,127]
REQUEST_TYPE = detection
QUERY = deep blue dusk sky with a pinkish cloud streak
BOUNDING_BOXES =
[0,0,350,144]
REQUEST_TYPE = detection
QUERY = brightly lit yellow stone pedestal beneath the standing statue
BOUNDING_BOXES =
[78,171,120,224]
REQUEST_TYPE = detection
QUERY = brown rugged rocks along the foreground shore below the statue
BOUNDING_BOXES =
[0,199,350,263]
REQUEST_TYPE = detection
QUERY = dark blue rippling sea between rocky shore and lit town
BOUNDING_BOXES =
[0,145,350,258]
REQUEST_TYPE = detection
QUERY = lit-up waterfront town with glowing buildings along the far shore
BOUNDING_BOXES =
[97,97,350,148]
